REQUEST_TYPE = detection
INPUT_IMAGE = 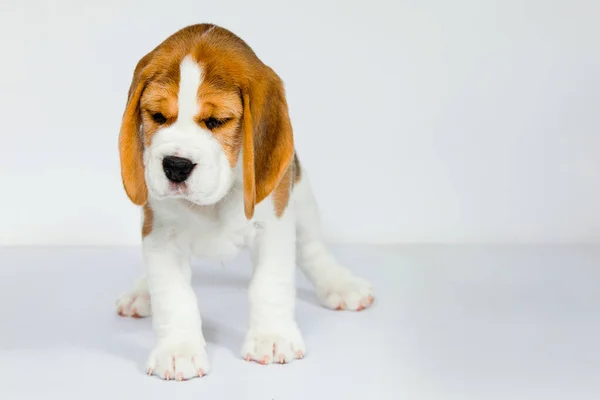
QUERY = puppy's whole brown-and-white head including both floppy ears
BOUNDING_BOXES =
[119,25,294,218]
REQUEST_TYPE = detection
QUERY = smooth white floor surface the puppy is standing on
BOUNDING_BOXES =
[0,246,600,400]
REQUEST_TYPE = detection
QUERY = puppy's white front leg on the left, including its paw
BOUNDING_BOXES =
[143,230,210,381]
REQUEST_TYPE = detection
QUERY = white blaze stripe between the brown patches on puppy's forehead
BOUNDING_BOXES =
[177,56,203,123]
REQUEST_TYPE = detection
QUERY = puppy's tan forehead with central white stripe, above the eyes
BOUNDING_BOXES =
[140,55,242,119]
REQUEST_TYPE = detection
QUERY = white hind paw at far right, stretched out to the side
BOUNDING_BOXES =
[316,271,374,311]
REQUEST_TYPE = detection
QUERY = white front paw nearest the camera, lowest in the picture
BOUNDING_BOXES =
[146,336,210,381]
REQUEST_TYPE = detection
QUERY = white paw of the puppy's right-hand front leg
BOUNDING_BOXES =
[242,323,306,365]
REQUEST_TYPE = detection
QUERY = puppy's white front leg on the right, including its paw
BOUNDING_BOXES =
[242,205,306,364]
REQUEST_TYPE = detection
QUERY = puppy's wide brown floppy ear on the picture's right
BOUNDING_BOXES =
[242,69,294,219]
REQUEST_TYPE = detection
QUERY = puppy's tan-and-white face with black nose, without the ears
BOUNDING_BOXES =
[140,56,243,205]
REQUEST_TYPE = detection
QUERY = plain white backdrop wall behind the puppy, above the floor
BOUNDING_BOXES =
[0,0,600,245]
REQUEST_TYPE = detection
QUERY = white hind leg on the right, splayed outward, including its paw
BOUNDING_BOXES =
[294,171,374,311]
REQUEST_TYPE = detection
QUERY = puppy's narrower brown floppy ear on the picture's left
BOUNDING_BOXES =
[119,57,148,206]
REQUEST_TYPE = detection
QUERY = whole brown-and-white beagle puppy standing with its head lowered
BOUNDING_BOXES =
[117,24,373,380]
